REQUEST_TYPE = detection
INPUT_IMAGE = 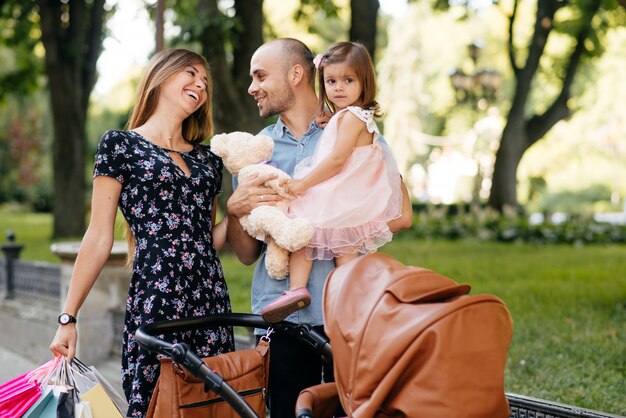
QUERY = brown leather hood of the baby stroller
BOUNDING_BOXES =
[320,254,512,418]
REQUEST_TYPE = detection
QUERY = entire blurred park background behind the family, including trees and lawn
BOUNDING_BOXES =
[0,0,626,415]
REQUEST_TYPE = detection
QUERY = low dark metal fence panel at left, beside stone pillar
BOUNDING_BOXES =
[0,258,61,302]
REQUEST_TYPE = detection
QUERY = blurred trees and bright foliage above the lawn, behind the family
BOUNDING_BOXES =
[0,0,626,238]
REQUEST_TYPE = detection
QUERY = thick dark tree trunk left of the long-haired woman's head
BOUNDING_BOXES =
[37,0,104,238]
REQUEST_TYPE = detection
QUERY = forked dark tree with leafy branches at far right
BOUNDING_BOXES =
[488,0,626,211]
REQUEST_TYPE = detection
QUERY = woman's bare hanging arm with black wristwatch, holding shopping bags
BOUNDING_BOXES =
[50,176,122,358]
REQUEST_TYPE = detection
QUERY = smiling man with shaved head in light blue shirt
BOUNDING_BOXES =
[227,39,411,418]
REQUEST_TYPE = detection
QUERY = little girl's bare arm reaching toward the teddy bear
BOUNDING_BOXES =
[286,112,364,196]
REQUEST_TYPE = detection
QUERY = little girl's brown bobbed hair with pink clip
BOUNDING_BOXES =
[317,42,382,117]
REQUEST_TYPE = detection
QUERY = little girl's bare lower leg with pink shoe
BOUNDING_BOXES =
[261,250,313,323]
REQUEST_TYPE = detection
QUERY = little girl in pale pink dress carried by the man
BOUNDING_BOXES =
[261,42,402,322]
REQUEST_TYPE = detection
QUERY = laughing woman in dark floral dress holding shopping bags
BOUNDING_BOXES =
[50,49,234,417]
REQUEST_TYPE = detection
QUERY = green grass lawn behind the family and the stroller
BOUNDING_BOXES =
[0,212,626,415]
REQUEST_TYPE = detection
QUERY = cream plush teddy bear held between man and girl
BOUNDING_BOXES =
[211,131,313,280]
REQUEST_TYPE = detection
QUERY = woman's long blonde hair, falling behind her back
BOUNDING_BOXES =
[125,49,213,265]
